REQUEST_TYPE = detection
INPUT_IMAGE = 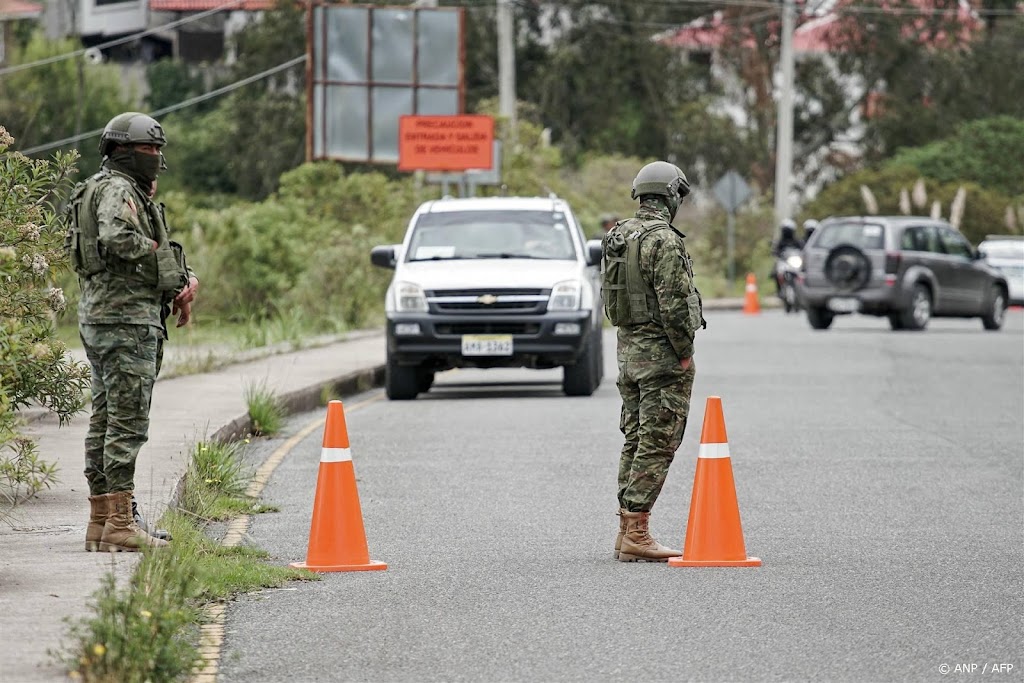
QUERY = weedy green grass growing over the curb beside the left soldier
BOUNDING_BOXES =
[58,439,318,683]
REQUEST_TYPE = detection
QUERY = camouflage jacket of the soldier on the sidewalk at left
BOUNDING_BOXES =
[78,169,175,327]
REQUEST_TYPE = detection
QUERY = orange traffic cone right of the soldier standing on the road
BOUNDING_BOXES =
[669,396,761,567]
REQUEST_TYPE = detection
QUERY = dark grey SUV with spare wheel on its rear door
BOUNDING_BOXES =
[797,216,1009,330]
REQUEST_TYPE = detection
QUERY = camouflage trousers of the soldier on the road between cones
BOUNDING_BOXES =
[616,360,695,512]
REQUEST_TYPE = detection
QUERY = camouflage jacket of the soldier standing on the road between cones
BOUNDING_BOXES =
[615,200,702,362]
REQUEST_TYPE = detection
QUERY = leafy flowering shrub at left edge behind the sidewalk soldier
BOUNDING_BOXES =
[0,131,89,503]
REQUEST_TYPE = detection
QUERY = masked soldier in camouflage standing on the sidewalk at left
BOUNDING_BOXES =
[66,112,199,552]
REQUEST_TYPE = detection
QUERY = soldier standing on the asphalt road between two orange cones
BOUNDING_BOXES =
[602,162,703,562]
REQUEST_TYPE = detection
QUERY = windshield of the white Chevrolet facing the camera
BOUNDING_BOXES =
[409,210,575,261]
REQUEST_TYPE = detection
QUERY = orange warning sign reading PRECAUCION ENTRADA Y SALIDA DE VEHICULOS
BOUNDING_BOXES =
[398,115,495,171]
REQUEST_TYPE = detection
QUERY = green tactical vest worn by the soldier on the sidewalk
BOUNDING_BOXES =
[65,169,188,292]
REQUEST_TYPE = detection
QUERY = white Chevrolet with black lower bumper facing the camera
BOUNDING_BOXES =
[371,197,604,399]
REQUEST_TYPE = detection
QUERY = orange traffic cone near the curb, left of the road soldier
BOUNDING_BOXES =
[291,400,387,571]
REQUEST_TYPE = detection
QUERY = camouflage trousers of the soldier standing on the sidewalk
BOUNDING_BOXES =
[79,324,164,496]
